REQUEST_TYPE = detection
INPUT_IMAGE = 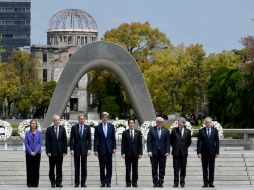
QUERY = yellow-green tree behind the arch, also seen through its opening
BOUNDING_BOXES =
[88,23,171,116]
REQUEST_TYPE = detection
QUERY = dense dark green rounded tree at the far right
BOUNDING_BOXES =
[208,67,248,128]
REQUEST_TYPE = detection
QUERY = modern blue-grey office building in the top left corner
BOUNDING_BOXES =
[0,0,31,60]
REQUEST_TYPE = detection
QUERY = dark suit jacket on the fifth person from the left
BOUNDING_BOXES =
[121,129,143,157]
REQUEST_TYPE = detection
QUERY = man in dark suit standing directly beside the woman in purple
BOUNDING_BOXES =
[45,115,67,187]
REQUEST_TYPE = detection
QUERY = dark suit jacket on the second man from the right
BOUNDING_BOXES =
[170,127,191,156]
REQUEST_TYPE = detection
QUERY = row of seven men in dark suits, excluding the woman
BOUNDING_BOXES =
[46,112,219,187]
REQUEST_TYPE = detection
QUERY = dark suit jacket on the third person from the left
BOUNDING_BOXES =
[70,124,92,156]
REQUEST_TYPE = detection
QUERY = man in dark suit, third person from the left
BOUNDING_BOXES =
[70,114,92,187]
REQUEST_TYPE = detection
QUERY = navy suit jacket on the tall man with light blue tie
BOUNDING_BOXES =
[94,123,116,154]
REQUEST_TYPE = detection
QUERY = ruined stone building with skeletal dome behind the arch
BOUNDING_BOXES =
[31,9,98,119]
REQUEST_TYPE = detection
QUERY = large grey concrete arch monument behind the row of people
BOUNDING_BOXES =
[43,41,155,127]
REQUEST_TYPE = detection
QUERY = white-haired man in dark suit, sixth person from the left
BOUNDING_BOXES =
[147,117,170,187]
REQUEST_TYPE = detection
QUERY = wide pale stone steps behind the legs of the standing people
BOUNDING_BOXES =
[0,150,254,188]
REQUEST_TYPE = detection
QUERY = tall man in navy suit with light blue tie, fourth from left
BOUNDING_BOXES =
[94,112,116,187]
